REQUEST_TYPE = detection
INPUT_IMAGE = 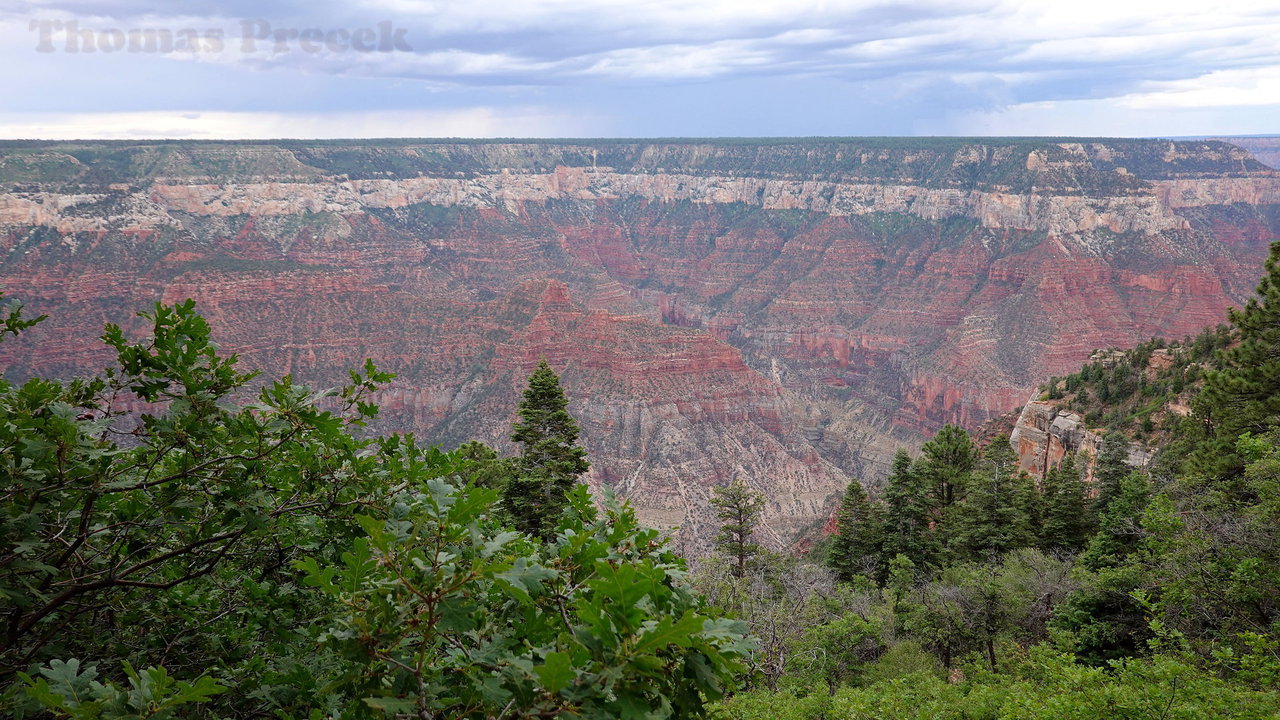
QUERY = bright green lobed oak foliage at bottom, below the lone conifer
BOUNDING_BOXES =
[303,478,749,719]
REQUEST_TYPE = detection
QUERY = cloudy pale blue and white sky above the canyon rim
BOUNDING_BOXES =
[0,0,1280,138]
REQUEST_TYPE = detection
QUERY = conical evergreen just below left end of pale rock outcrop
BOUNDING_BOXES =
[955,441,1036,561]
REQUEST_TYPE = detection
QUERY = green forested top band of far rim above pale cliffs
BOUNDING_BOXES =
[0,137,1267,184]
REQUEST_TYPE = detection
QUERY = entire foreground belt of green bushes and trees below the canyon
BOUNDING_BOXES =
[0,243,1280,719]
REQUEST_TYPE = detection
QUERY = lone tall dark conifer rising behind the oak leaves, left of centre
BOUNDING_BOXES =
[503,360,590,539]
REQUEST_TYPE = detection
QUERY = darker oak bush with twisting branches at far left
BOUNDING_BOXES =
[0,295,390,674]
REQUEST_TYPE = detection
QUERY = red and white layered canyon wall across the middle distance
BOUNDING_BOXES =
[0,138,1280,547]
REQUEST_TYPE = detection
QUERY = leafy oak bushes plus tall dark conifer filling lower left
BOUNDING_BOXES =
[0,295,751,719]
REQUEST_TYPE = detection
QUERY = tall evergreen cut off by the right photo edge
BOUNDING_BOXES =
[1189,242,1280,480]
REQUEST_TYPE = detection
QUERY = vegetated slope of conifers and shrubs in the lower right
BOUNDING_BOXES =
[695,243,1280,720]
